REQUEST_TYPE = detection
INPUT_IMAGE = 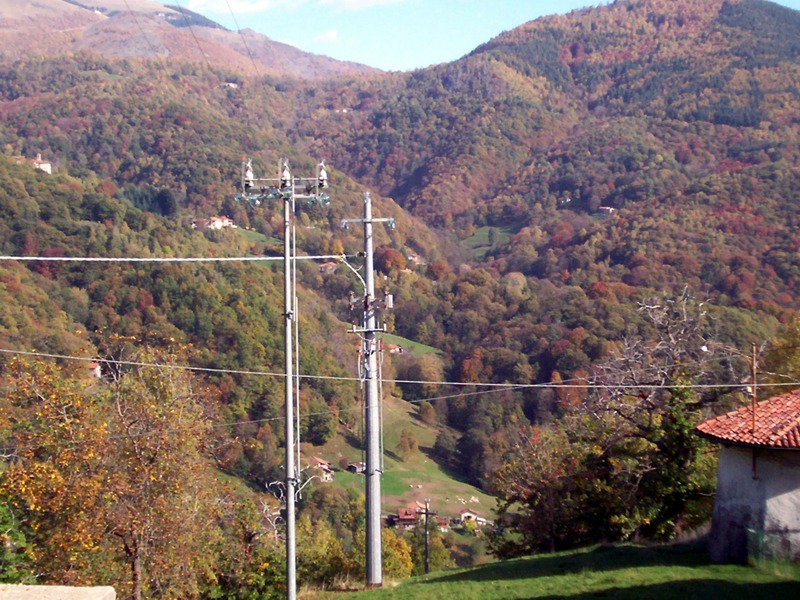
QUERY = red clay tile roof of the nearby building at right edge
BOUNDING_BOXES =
[697,390,800,450]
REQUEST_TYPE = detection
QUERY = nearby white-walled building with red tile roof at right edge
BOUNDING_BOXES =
[697,390,800,563]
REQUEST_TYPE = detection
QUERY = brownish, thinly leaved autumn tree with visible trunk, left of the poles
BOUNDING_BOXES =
[103,356,219,597]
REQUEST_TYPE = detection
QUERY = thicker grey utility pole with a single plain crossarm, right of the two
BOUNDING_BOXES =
[342,192,394,587]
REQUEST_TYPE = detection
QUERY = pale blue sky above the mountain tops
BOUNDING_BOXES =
[182,0,800,71]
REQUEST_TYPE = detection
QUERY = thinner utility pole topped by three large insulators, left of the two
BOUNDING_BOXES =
[237,159,330,600]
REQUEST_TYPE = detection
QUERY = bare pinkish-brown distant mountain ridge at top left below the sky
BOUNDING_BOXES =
[0,0,380,79]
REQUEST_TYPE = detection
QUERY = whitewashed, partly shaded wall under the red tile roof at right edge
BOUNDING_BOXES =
[709,446,800,562]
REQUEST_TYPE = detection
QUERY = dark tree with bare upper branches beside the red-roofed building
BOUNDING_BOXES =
[492,295,728,556]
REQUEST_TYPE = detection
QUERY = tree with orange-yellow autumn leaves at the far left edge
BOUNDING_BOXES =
[0,360,115,584]
